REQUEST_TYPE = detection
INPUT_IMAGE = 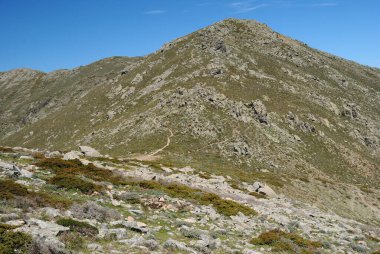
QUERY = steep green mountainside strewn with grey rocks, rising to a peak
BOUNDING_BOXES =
[0,19,380,225]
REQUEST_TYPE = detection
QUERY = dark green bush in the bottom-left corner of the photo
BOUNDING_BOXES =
[0,224,32,254]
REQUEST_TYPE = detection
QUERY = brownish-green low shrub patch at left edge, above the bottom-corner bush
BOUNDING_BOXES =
[0,179,71,208]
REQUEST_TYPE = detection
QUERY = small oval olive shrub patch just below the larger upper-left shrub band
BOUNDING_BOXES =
[49,173,103,194]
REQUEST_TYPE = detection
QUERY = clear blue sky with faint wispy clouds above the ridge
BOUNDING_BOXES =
[0,0,380,71]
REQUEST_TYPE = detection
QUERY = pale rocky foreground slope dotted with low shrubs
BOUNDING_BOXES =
[0,147,380,253]
